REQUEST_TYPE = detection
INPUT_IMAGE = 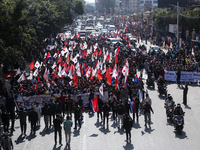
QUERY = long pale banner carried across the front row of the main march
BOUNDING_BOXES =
[15,92,108,110]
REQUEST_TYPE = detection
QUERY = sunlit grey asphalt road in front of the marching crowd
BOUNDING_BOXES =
[2,83,200,150]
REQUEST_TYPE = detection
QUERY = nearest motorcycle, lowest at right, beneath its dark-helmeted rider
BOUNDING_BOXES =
[174,115,184,134]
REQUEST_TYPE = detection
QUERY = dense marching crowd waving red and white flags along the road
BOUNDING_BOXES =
[0,16,199,149]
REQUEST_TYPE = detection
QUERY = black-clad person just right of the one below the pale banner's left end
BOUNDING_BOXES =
[28,107,38,134]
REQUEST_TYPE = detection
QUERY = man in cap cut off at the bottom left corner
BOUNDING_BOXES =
[0,132,13,150]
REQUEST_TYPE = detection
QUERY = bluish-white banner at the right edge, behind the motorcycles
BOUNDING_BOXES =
[165,70,200,82]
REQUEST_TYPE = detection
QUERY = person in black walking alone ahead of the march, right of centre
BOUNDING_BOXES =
[123,113,133,142]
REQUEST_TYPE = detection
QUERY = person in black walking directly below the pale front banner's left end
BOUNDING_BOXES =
[19,107,27,136]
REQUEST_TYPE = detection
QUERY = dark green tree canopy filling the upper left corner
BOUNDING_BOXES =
[0,0,84,72]
